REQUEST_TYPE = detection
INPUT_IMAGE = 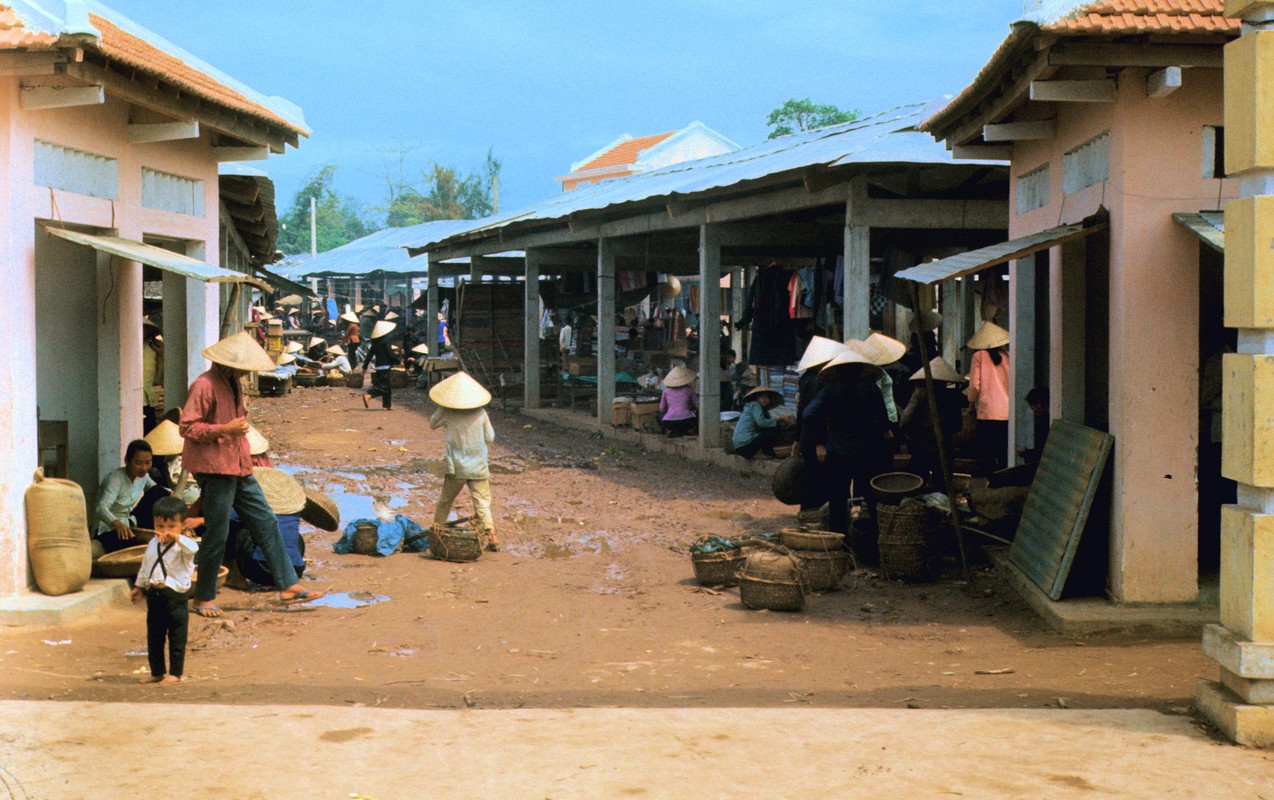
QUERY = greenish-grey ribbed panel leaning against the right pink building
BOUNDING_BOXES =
[1009,419,1115,600]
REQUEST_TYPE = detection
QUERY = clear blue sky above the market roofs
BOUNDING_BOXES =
[106,0,1022,219]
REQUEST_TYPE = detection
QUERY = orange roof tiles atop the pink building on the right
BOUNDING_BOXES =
[1043,0,1241,34]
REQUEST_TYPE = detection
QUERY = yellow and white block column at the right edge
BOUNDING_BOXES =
[1196,0,1274,746]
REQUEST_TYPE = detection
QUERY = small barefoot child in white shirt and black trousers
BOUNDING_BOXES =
[131,497,199,687]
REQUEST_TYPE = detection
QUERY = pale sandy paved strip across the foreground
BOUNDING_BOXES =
[0,703,1274,800]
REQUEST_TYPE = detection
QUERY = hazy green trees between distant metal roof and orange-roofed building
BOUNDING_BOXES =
[385,150,501,228]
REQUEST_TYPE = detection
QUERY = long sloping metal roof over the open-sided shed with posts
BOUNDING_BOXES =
[412,98,1003,252]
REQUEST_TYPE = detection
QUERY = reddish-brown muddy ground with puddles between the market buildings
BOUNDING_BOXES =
[0,389,1215,712]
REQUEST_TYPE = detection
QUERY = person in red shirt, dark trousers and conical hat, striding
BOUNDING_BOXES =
[178,332,324,617]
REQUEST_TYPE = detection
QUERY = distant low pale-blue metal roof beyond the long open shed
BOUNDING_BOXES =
[274,219,475,280]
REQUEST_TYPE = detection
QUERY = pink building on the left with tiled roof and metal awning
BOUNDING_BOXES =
[0,0,310,619]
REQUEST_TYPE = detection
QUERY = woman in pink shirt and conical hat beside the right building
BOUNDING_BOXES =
[968,322,1009,473]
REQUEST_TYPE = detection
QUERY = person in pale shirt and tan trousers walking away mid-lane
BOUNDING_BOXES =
[429,372,499,552]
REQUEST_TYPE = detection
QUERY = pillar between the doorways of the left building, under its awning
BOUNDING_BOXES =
[96,252,143,478]
